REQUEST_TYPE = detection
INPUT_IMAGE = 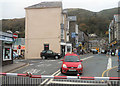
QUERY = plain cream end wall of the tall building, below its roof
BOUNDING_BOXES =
[25,8,61,59]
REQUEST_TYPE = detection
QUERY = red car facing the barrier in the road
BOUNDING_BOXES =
[61,53,83,75]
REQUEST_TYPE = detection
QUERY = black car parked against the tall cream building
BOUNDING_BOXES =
[40,50,61,59]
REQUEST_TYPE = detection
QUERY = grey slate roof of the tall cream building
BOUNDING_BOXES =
[25,1,62,9]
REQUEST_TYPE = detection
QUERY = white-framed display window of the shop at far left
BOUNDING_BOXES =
[3,47,12,61]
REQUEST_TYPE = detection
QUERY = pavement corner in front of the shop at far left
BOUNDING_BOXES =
[2,62,28,73]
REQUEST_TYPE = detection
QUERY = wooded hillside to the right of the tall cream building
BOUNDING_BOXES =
[65,8,118,37]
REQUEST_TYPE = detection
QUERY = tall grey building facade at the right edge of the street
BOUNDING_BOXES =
[109,14,120,49]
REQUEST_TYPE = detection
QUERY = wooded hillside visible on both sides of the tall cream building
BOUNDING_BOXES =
[2,8,118,37]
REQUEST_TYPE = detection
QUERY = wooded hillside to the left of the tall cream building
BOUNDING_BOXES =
[2,18,25,38]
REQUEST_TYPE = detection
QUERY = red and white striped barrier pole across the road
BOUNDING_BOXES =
[0,73,120,80]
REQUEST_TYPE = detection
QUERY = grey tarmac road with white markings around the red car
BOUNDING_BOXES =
[10,54,117,84]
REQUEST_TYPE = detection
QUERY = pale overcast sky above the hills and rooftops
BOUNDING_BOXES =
[0,0,119,19]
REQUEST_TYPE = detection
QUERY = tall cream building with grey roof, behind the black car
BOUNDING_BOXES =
[25,2,71,59]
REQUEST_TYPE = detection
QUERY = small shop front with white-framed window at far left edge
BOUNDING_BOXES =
[0,32,13,65]
